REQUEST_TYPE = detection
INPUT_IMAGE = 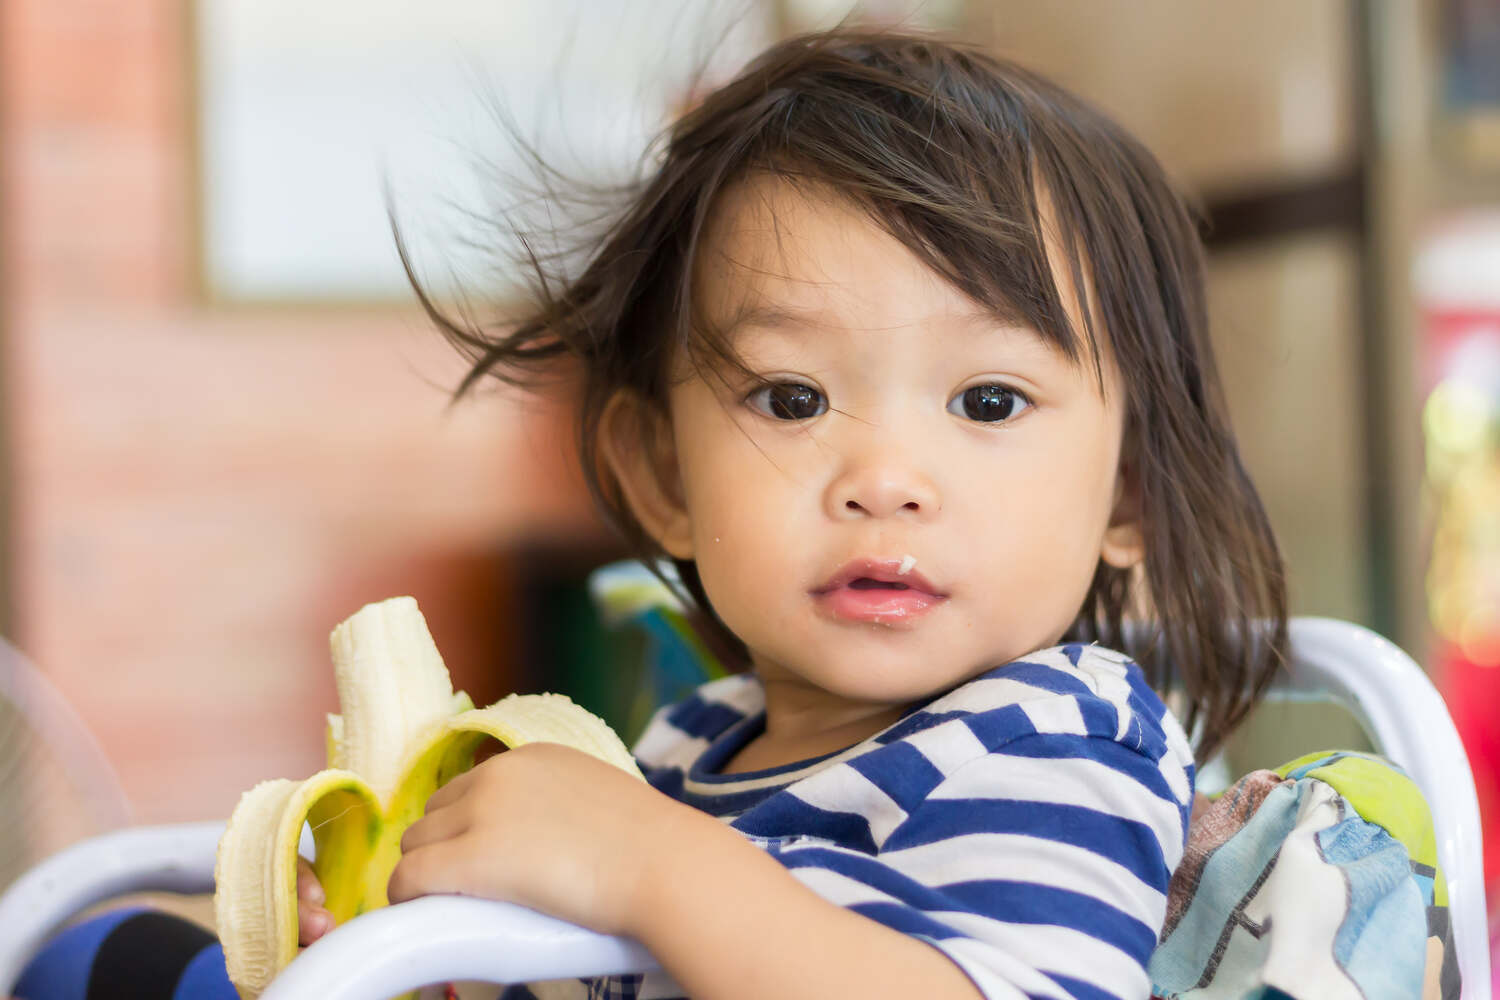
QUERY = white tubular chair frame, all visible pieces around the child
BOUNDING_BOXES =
[0,618,1491,1000]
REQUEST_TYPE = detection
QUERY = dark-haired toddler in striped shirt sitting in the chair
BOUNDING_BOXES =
[11,28,1286,1000]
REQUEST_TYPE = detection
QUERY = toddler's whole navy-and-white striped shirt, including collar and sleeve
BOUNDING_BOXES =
[558,645,1194,1000]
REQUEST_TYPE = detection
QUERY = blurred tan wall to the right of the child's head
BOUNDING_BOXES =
[969,0,1431,772]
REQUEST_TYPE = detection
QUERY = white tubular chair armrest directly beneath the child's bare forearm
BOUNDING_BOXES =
[261,895,660,1000]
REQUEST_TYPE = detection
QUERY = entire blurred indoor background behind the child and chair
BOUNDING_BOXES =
[0,0,1500,953]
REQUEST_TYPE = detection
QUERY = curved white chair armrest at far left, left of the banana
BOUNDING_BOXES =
[0,820,224,996]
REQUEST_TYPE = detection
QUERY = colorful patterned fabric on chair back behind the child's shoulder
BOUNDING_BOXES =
[1149,751,1460,1000]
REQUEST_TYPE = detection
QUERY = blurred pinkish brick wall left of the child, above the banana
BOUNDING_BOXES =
[0,0,596,822]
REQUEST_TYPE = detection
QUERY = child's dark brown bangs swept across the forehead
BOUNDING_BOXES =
[672,109,1103,388]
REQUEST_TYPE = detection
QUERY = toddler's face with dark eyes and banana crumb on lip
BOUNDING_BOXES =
[609,180,1140,708]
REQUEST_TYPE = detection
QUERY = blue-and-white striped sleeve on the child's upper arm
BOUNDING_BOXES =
[756,733,1188,1000]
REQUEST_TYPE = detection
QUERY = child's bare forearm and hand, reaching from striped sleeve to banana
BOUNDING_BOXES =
[390,744,980,1000]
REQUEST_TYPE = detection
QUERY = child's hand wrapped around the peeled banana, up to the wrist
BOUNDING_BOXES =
[389,744,698,934]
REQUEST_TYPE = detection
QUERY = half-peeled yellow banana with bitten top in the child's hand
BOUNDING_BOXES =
[213,597,641,1000]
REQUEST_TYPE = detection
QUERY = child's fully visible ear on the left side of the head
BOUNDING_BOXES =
[599,390,693,559]
